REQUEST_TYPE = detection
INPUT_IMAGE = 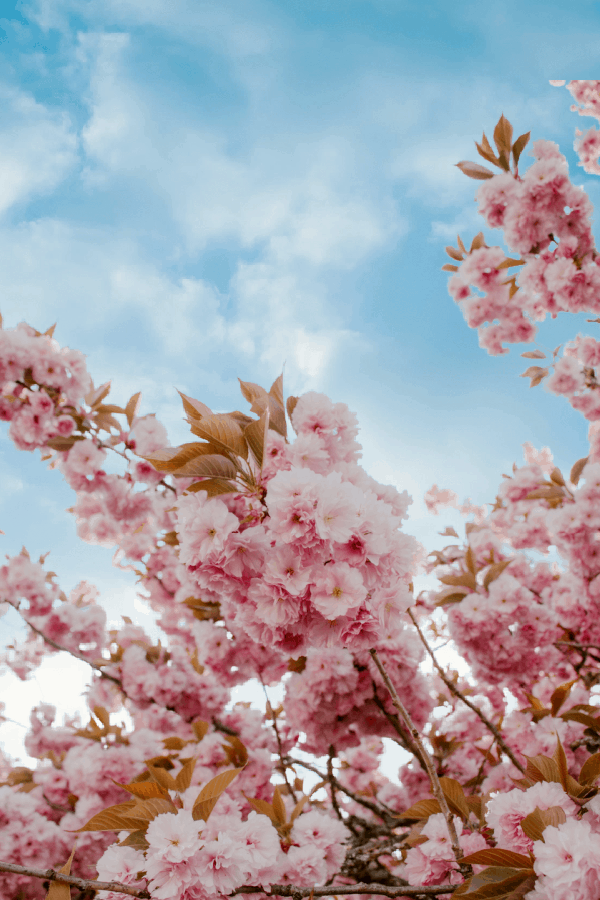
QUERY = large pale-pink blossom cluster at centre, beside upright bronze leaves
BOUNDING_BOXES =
[175,392,419,656]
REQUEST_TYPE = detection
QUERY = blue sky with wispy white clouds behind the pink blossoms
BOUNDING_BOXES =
[0,0,600,760]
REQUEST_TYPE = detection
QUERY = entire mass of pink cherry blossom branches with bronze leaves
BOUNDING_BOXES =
[0,81,600,900]
